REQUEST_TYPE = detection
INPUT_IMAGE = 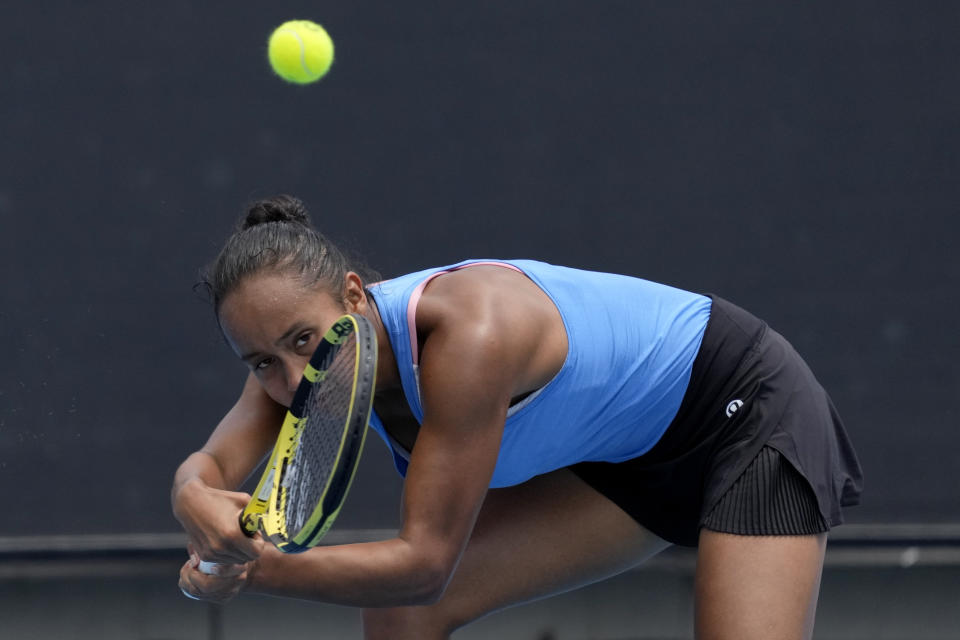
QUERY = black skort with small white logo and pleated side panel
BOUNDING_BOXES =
[571,296,862,547]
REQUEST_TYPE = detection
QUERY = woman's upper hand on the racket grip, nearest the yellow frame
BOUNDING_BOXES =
[174,480,264,565]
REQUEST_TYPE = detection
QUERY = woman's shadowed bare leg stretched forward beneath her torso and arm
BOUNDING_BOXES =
[363,470,669,640]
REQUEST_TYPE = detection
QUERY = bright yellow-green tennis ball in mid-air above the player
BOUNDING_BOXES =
[267,20,333,84]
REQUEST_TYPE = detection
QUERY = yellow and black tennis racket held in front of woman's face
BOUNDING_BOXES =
[198,314,377,573]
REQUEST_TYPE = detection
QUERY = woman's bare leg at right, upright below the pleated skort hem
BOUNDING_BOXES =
[696,529,827,640]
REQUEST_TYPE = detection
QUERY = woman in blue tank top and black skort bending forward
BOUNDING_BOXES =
[172,196,861,640]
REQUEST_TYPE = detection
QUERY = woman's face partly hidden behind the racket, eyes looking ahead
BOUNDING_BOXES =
[220,273,365,406]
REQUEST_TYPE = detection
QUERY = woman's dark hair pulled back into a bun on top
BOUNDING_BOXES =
[199,195,378,313]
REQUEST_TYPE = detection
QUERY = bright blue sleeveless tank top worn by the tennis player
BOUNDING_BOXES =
[370,260,711,487]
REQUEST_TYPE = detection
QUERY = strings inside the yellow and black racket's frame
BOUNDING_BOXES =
[283,334,356,537]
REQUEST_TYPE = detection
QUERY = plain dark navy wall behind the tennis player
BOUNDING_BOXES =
[0,0,960,535]
